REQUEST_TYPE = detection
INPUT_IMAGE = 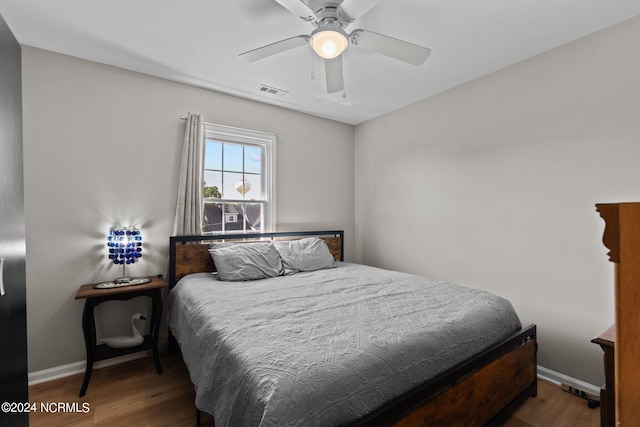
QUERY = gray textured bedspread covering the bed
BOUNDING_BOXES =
[169,263,521,427]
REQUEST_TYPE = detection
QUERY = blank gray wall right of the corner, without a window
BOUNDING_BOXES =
[355,18,640,386]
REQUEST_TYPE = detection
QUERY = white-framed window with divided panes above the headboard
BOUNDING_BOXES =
[202,123,276,233]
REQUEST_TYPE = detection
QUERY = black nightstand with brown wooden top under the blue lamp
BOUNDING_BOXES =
[75,276,168,397]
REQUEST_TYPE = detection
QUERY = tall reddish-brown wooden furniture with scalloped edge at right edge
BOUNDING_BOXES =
[596,203,640,427]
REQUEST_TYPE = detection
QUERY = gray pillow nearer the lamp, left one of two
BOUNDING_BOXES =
[209,242,284,282]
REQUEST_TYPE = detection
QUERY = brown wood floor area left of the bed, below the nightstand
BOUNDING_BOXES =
[29,355,195,427]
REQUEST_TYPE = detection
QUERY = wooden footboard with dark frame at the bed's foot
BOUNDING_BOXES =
[354,325,537,427]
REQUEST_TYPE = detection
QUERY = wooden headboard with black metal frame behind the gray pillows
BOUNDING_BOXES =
[168,230,344,289]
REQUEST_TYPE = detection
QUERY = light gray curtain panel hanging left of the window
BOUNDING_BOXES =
[173,113,205,236]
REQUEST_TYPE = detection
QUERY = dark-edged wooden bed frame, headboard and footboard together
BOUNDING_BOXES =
[168,230,538,427]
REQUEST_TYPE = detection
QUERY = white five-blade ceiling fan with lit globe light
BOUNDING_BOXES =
[239,0,431,93]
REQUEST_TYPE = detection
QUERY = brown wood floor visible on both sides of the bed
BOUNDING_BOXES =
[29,355,600,427]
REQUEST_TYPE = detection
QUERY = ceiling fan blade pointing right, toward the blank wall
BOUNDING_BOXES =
[350,30,431,65]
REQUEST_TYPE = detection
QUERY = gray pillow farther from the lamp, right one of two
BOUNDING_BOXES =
[274,237,336,274]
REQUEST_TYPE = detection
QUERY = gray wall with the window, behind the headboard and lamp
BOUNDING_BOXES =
[23,47,354,372]
